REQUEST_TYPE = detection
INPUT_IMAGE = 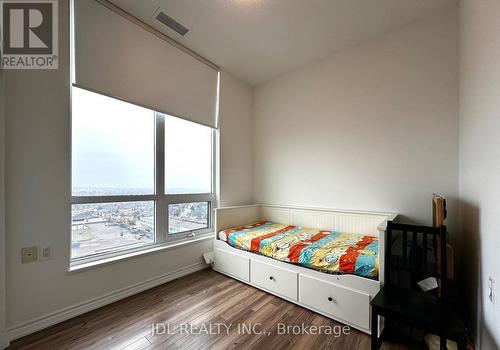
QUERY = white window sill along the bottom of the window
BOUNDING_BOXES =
[68,232,214,273]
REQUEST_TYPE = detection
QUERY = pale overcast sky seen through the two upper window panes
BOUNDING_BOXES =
[72,87,211,193]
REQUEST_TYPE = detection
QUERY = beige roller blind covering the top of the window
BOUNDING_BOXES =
[74,0,219,127]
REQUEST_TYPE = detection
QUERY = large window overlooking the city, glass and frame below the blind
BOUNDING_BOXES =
[71,87,215,264]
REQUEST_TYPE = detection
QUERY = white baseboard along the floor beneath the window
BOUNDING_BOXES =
[6,262,207,342]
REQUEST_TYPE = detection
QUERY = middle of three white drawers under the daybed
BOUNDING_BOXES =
[250,260,297,300]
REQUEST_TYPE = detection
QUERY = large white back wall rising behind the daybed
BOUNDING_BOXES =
[254,6,458,231]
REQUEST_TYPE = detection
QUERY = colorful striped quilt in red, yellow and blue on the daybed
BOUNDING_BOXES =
[219,221,379,279]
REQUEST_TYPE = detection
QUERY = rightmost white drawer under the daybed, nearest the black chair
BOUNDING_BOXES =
[299,275,370,330]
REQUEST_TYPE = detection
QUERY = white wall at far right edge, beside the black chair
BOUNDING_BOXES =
[460,0,500,350]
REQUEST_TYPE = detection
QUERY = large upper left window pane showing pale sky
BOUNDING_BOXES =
[72,88,155,196]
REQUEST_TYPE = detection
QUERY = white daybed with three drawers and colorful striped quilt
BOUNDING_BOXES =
[214,204,396,333]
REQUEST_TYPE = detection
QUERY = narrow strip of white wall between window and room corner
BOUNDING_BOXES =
[219,71,253,206]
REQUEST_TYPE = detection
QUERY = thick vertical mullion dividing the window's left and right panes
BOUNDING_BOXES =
[155,113,168,243]
